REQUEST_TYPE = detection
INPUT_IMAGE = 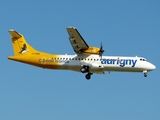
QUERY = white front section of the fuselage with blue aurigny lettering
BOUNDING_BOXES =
[46,54,155,74]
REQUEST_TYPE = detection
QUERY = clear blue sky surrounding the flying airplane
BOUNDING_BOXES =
[0,0,160,120]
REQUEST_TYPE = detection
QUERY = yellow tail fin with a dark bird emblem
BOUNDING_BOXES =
[8,30,38,56]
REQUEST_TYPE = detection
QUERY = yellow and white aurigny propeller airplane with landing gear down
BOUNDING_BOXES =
[8,27,156,80]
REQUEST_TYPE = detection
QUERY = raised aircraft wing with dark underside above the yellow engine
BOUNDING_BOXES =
[66,27,89,54]
